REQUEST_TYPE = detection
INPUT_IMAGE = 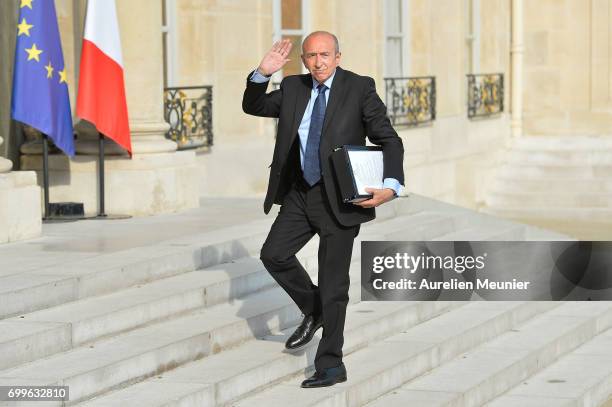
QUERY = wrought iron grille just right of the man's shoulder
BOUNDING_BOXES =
[384,76,436,126]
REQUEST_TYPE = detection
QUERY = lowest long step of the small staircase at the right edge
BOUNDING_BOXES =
[486,187,612,208]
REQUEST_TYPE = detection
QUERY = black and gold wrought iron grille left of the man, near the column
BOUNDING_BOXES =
[164,86,213,150]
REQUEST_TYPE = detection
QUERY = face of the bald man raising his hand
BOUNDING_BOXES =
[302,34,340,83]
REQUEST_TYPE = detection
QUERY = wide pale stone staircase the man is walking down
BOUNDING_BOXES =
[0,196,612,407]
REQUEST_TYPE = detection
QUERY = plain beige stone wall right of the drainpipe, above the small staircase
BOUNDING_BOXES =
[523,0,612,135]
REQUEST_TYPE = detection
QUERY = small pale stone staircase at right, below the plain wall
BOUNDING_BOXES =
[483,136,612,240]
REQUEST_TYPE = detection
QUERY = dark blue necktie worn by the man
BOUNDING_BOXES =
[304,84,327,186]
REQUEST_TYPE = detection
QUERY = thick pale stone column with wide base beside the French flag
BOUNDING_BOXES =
[22,0,199,215]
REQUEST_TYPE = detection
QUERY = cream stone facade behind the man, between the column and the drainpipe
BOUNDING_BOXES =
[175,0,510,207]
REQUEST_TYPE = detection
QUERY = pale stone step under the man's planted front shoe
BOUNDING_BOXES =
[232,302,557,407]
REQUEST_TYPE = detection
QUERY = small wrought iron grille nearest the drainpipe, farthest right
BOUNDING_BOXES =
[467,73,504,119]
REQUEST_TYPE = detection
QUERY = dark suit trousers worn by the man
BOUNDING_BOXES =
[261,178,360,370]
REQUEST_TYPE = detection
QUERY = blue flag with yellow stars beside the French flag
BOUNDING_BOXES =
[11,0,74,157]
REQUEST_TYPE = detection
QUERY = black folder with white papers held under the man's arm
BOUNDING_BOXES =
[331,145,383,202]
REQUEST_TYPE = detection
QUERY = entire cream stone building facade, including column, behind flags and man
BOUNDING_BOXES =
[0,0,612,236]
